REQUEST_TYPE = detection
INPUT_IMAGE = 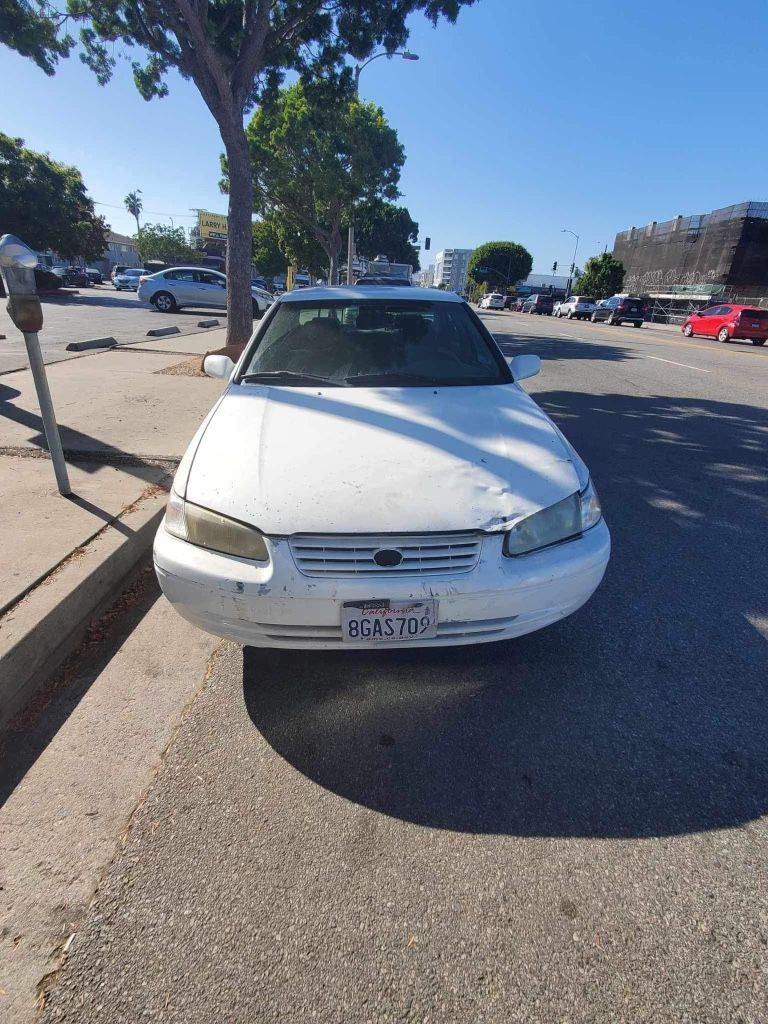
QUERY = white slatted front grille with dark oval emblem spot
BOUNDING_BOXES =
[290,534,480,578]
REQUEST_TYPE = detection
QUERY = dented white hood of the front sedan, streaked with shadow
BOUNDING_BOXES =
[183,384,579,536]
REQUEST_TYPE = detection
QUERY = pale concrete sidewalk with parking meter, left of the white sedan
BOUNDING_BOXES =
[0,330,225,728]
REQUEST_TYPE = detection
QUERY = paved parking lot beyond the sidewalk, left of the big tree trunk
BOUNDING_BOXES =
[0,285,226,373]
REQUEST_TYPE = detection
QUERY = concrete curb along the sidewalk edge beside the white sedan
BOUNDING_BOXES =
[0,492,166,729]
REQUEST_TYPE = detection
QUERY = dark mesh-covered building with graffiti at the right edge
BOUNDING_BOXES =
[613,203,768,305]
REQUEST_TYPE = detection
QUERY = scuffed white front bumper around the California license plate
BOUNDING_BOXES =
[155,520,610,650]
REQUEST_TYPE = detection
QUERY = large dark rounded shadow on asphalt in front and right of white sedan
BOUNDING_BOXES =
[243,391,768,838]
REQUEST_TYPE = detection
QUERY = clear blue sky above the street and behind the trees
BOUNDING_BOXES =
[0,0,768,272]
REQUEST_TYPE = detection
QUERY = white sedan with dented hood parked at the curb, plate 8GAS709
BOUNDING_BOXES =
[155,287,610,649]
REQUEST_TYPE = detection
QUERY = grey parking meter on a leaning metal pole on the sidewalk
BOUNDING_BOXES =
[0,234,72,496]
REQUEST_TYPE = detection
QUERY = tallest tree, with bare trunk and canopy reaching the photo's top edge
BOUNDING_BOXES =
[0,0,474,343]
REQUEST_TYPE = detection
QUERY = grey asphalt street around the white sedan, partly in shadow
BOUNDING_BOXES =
[44,313,768,1024]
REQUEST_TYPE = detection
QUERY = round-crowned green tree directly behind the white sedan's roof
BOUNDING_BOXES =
[244,82,404,284]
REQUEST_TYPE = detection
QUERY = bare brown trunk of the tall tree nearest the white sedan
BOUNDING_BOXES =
[221,127,253,345]
